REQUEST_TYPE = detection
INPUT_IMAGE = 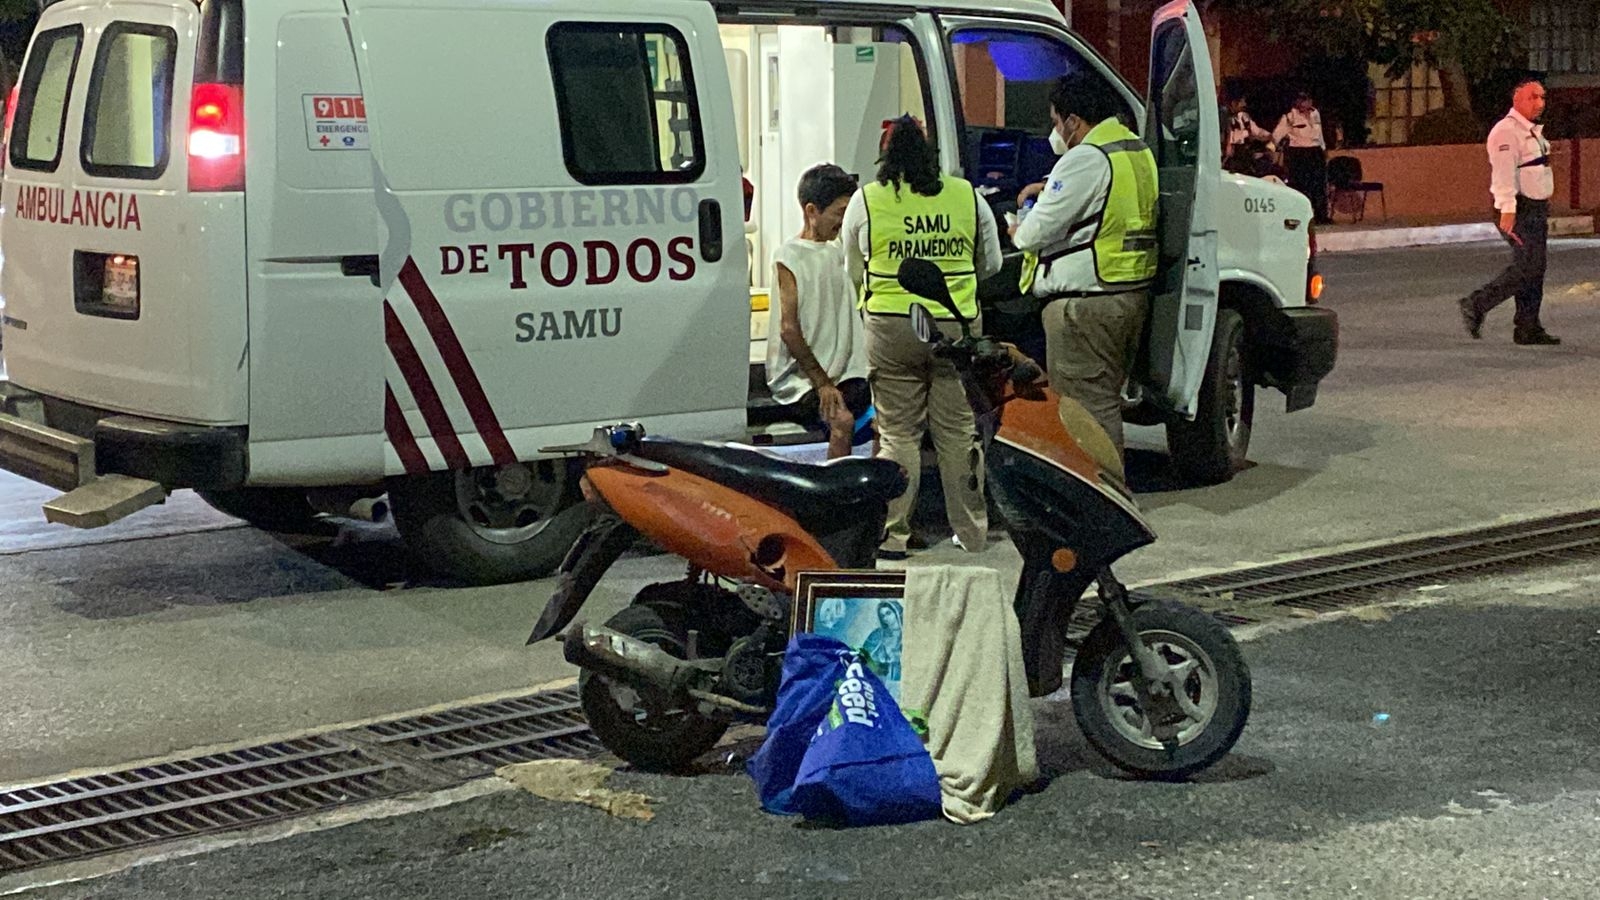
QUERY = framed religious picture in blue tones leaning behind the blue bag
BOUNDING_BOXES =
[789,569,906,703]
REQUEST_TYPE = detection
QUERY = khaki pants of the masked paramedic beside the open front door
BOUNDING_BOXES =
[1045,290,1150,456]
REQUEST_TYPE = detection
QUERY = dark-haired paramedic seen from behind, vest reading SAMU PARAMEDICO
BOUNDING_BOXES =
[843,115,1002,559]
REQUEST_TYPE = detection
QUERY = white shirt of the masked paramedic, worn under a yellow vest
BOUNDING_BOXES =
[1011,137,1128,296]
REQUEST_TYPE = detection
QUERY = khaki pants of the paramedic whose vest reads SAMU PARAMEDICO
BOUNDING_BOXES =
[867,315,989,551]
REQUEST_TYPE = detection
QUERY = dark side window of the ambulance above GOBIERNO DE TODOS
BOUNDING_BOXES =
[549,22,706,184]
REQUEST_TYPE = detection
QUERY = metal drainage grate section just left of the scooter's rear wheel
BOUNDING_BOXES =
[363,687,605,773]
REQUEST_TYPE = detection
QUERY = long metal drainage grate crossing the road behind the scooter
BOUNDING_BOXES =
[15,511,1600,873]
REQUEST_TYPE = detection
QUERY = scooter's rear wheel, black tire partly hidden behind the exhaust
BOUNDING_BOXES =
[578,605,730,772]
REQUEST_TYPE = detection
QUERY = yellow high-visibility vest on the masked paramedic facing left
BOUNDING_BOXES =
[1021,119,1160,293]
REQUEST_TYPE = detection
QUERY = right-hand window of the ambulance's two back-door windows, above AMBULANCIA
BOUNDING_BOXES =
[83,22,178,179]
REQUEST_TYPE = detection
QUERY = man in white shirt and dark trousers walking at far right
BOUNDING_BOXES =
[1458,78,1562,346]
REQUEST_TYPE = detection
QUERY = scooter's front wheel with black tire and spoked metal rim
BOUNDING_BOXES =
[1072,602,1250,780]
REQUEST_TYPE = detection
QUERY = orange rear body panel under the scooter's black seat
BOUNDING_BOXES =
[587,466,838,593]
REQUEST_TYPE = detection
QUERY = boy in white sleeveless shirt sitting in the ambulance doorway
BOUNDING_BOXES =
[766,163,872,460]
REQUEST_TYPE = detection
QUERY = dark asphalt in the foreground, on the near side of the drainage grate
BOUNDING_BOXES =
[25,564,1600,900]
